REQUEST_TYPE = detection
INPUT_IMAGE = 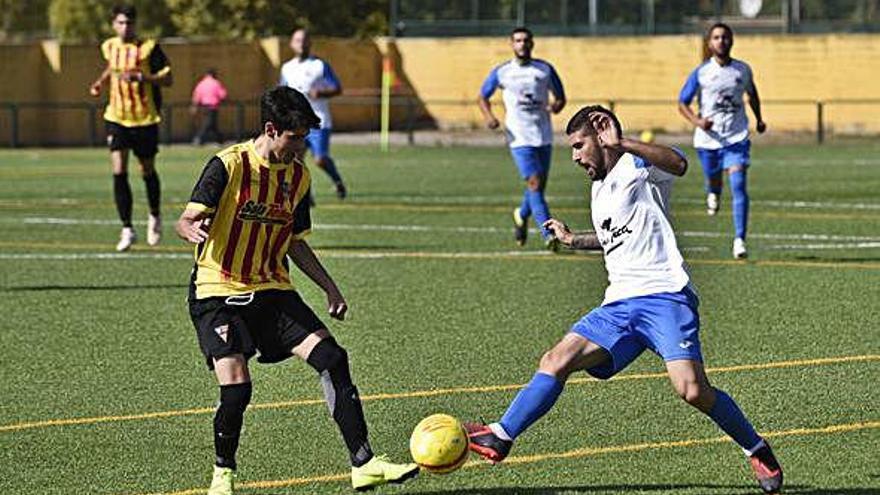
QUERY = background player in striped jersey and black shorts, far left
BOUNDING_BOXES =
[89,5,172,251]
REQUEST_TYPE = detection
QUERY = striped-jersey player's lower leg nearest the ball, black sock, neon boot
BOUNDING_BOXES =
[306,337,419,491]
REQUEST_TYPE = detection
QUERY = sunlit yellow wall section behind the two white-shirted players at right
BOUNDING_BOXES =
[397,35,880,132]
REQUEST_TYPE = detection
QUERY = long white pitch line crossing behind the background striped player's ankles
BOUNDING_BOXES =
[13,217,880,245]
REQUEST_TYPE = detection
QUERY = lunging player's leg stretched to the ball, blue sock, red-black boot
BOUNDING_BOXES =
[464,333,608,464]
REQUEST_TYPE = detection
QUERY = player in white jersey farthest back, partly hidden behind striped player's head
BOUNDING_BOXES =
[278,29,347,200]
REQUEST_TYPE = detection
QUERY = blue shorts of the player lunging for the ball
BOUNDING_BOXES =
[571,287,703,380]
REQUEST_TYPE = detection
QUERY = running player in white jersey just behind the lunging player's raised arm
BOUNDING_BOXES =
[477,27,565,250]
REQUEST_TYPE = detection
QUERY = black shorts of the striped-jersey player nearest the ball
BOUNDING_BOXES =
[189,290,327,369]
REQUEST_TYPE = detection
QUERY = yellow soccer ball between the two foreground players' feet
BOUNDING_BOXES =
[409,414,468,474]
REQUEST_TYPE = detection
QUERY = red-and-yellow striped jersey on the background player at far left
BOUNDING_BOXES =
[101,37,171,127]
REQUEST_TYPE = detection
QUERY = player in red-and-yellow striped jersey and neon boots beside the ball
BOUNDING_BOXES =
[176,86,419,495]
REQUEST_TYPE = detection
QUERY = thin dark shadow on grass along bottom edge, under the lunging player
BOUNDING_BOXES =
[410,483,880,495]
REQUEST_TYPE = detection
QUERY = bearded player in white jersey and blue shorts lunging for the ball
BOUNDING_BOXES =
[465,106,782,493]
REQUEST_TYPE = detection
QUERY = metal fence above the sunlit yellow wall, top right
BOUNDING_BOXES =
[389,0,880,37]
